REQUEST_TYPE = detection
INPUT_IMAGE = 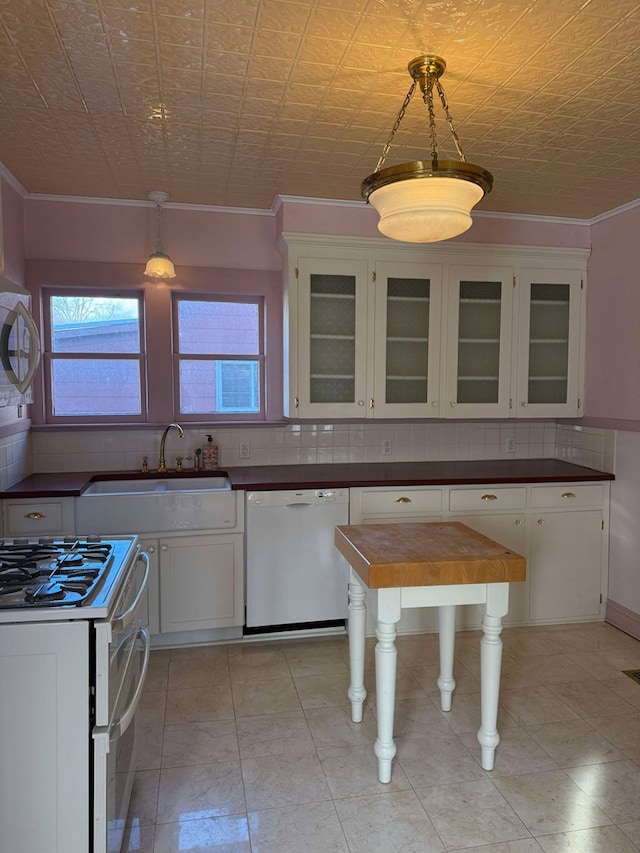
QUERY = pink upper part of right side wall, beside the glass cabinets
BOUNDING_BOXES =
[585,207,640,428]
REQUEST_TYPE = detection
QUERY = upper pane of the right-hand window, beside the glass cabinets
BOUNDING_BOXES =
[178,299,260,352]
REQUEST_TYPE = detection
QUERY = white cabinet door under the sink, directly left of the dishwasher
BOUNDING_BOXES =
[159,533,244,634]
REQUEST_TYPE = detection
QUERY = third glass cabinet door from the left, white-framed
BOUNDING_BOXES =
[445,267,513,418]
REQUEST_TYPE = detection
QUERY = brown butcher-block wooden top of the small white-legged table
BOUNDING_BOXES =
[335,521,527,589]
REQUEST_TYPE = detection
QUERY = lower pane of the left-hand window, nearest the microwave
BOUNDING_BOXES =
[51,358,142,417]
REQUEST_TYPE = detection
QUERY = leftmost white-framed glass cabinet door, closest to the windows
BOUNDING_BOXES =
[297,259,367,417]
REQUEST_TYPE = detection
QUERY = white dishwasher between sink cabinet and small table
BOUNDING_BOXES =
[245,488,349,634]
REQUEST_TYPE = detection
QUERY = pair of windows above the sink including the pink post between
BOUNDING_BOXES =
[40,283,266,424]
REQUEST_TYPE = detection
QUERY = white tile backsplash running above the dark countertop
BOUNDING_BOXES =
[0,421,615,489]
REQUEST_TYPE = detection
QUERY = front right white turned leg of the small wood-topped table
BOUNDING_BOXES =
[478,614,502,770]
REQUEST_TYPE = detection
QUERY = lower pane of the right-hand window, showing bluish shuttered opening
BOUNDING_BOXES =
[180,359,260,415]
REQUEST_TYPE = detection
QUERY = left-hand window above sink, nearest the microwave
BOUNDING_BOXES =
[44,291,145,422]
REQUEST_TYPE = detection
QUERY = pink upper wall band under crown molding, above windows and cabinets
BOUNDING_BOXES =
[23,196,589,270]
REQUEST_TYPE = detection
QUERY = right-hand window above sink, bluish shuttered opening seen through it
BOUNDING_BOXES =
[174,296,264,418]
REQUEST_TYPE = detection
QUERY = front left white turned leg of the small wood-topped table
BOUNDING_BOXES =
[373,621,398,783]
